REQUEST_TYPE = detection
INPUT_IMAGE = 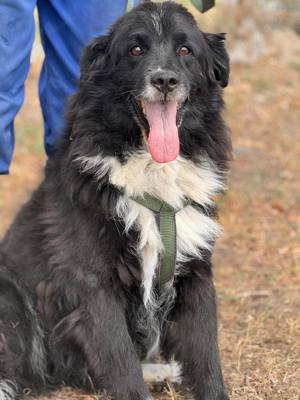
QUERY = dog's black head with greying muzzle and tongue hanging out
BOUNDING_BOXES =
[72,2,229,162]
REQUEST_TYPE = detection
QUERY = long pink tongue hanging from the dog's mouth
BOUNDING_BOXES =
[143,101,179,163]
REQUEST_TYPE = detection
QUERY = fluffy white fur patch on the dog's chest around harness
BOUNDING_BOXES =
[81,152,223,305]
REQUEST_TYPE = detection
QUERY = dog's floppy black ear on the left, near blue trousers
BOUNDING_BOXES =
[80,36,109,82]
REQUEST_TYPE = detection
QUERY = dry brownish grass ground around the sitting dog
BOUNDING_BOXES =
[0,35,300,400]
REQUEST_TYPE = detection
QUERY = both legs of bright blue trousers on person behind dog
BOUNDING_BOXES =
[0,0,139,174]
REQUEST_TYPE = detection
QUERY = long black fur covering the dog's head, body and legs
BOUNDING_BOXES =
[0,2,230,400]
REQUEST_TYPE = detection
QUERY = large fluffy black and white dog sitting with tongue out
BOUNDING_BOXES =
[0,2,230,400]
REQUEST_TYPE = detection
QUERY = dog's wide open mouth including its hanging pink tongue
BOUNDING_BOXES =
[131,99,185,163]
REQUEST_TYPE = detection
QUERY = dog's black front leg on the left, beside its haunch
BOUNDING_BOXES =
[88,290,151,400]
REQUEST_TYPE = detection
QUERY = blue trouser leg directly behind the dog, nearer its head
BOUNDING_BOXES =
[37,0,139,156]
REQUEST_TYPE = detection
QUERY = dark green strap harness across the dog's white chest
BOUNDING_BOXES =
[131,193,191,289]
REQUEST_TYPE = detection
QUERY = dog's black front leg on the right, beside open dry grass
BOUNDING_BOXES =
[164,261,229,400]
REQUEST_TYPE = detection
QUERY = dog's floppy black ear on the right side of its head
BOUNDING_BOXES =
[204,33,230,87]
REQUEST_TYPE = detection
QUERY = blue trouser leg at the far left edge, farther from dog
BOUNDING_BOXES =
[0,0,35,174]
